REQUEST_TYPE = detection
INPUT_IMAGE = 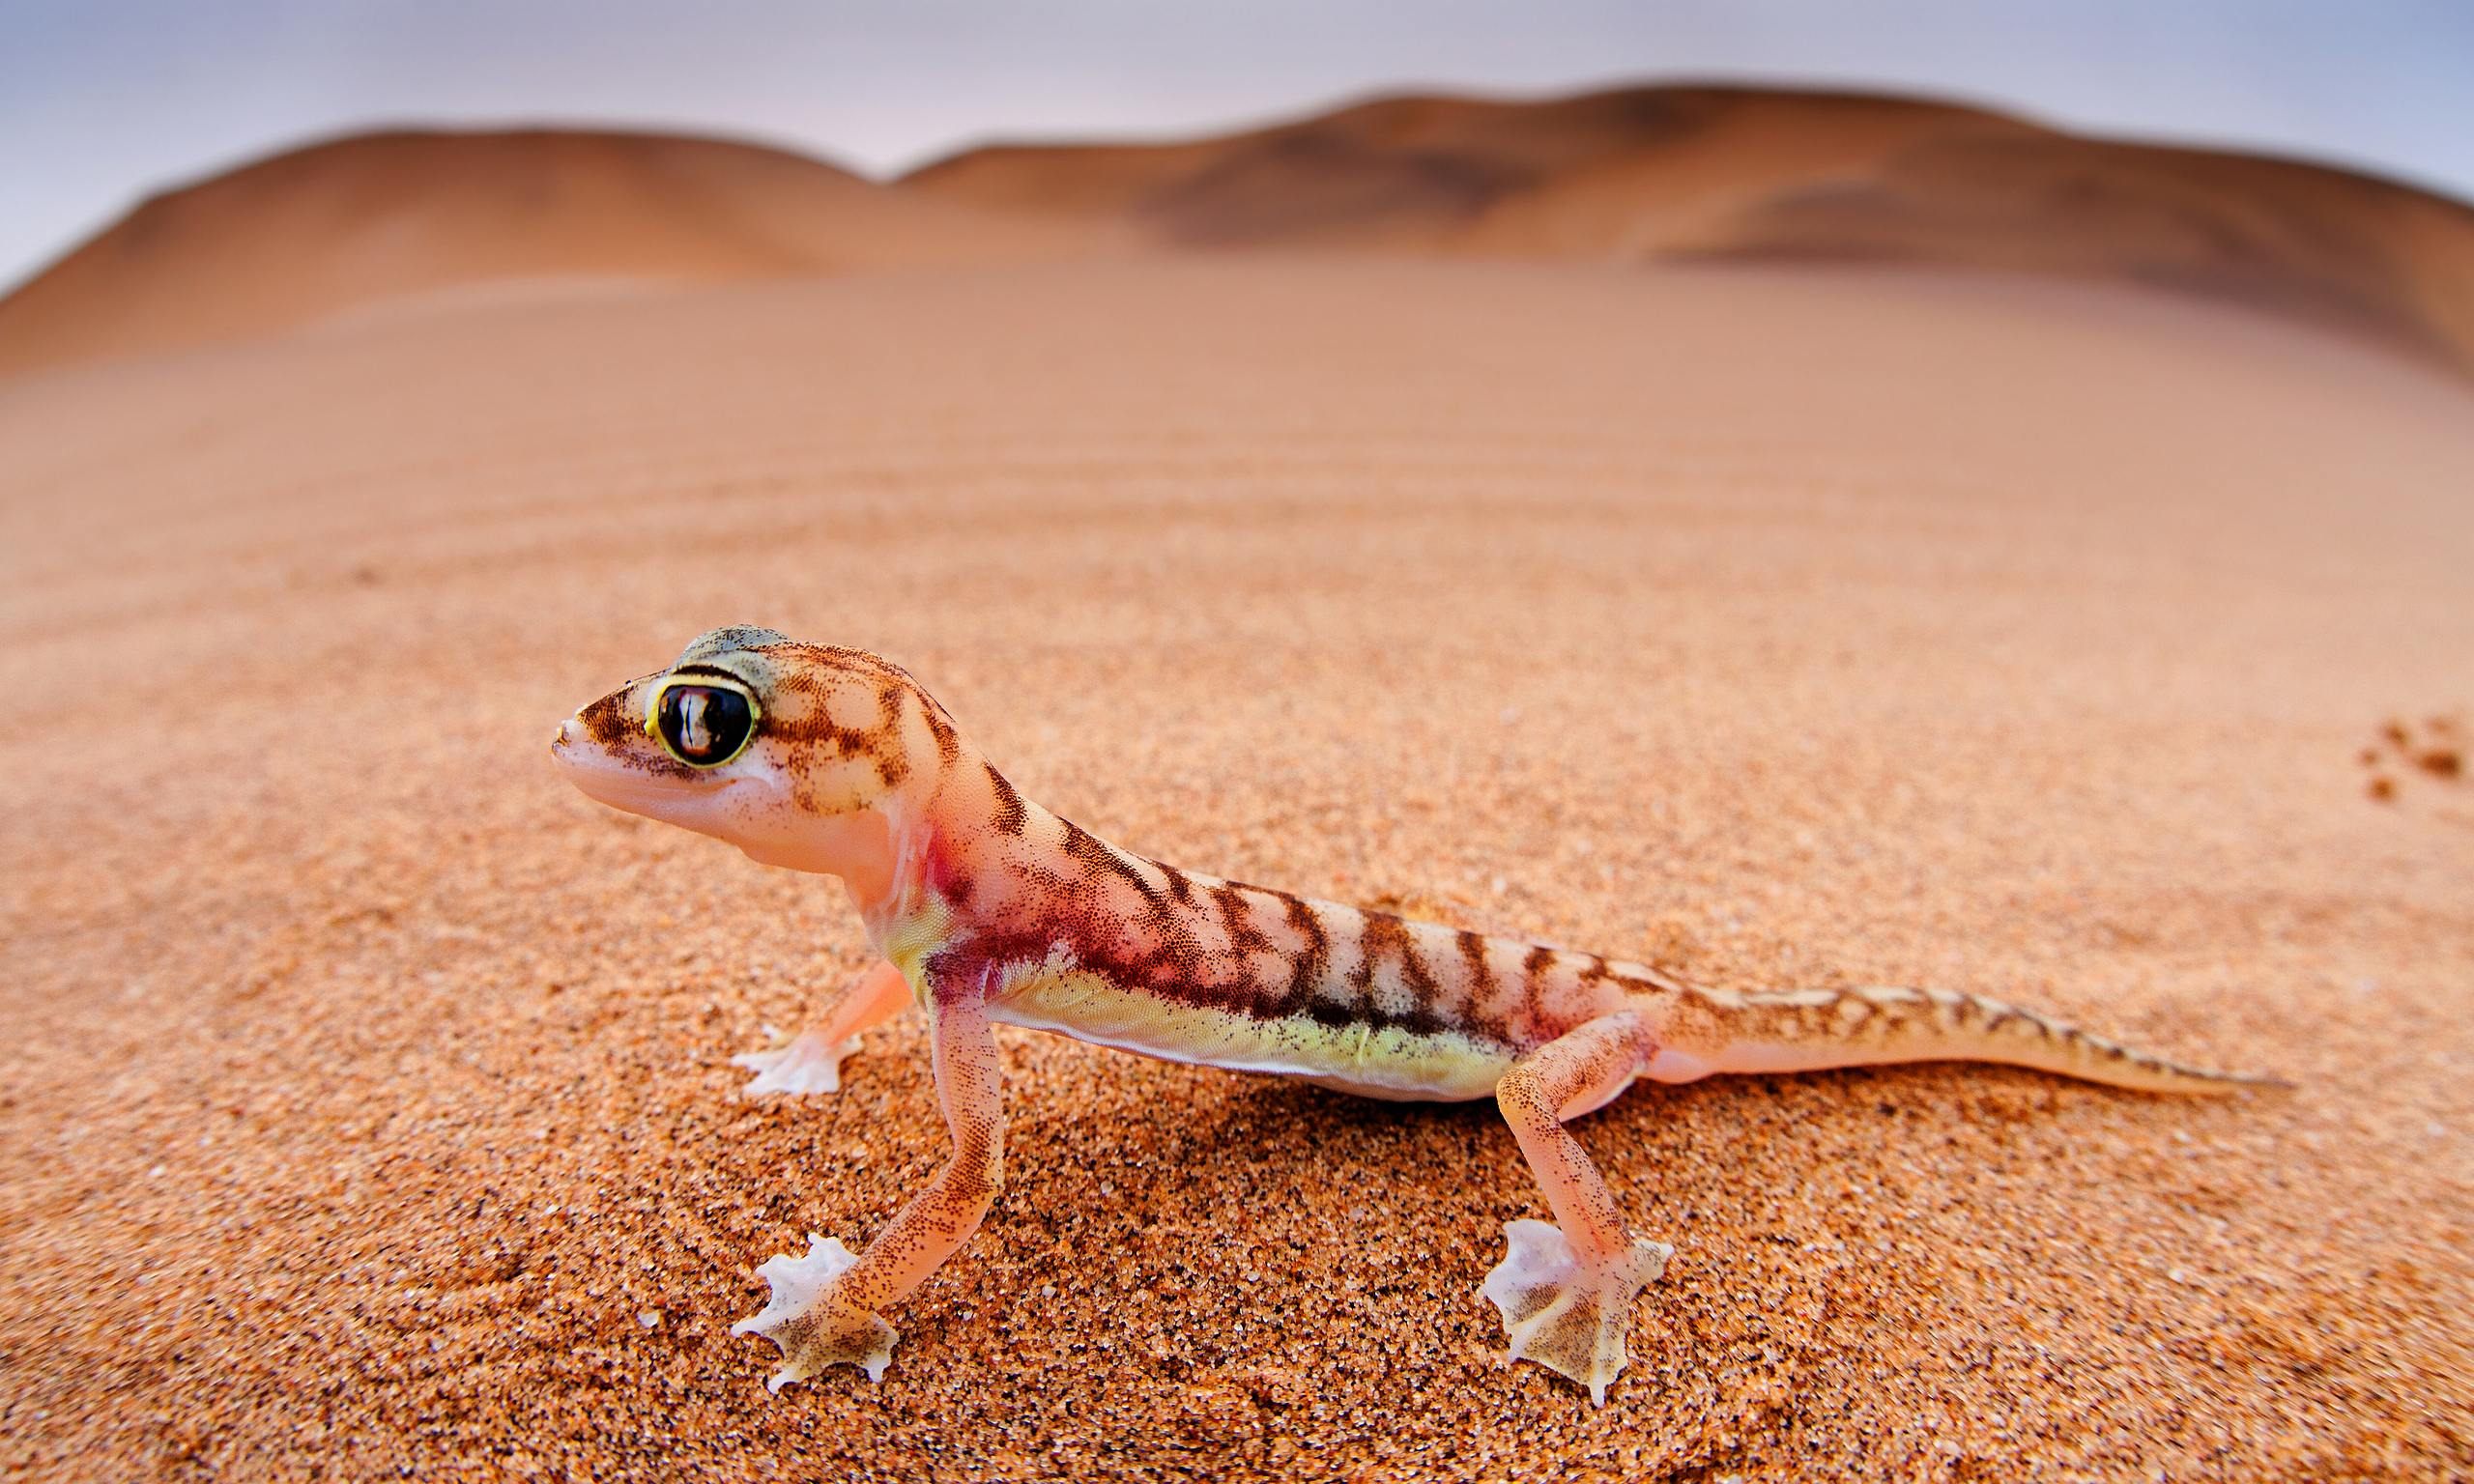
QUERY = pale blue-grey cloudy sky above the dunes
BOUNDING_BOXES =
[0,0,2474,284]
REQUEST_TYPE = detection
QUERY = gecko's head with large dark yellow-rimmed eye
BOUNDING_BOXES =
[549,628,958,875]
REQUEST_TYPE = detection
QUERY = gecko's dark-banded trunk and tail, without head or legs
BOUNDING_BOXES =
[915,764,2265,1100]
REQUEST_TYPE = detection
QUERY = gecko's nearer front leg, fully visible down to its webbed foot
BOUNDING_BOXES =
[730,985,1004,1390]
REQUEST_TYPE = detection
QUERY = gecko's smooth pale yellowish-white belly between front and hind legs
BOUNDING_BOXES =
[987,972,1511,1100]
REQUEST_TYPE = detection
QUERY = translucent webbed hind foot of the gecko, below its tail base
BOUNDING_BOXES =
[1477,1222,1675,1408]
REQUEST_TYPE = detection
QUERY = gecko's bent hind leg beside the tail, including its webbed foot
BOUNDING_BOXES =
[1480,1012,1675,1408]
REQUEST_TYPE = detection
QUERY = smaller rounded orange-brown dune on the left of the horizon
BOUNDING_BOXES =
[0,131,1108,374]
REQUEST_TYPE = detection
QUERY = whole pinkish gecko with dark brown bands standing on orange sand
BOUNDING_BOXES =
[552,626,2281,1405]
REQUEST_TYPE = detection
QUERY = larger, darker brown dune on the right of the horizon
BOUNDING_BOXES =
[906,87,2474,366]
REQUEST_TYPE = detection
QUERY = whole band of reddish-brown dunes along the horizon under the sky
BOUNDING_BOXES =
[0,87,2474,376]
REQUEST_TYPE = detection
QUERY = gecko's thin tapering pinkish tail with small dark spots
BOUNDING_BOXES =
[1648,986,2291,1096]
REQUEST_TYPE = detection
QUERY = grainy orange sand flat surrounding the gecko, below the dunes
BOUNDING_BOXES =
[0,257,2474,1481]
